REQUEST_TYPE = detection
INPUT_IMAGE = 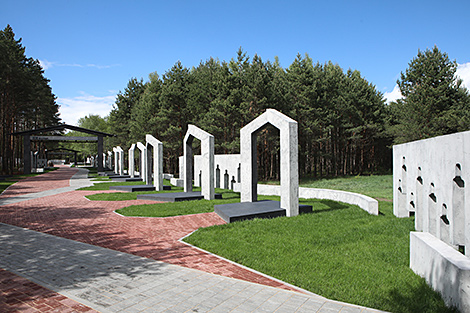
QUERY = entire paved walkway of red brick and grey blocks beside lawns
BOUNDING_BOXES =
[0,167,384,312]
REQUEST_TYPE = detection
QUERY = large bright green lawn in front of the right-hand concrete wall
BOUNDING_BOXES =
[184,200,456,313]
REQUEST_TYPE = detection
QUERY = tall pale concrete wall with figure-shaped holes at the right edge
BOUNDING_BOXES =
[393,132,470,312]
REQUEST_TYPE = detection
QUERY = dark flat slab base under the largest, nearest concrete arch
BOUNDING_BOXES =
[214,200,312,223]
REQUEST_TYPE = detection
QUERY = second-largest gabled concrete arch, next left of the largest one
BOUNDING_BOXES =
[183,124,215,200]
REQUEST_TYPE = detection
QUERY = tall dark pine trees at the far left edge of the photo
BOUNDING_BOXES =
[0,25,60,174]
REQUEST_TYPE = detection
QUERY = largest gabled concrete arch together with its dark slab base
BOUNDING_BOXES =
[214,109,312,223]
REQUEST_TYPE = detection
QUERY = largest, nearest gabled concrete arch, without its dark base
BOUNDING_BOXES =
[240,109,299,216]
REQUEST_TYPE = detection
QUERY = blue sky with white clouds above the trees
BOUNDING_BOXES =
[0,0,470,124]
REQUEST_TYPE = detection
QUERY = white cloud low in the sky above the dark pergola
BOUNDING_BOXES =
[57,93,116,126]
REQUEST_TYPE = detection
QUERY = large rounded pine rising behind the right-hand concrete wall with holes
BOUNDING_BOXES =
[390,46,470,143]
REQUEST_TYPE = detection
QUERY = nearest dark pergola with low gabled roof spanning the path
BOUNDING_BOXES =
[11,124,115,174]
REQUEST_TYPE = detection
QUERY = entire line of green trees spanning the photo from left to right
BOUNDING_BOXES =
[0,22,470,179]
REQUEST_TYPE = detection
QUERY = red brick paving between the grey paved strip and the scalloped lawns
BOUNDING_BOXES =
[0,168,302,310]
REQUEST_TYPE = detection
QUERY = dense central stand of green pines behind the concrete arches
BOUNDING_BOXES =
[109,49,391,179]
